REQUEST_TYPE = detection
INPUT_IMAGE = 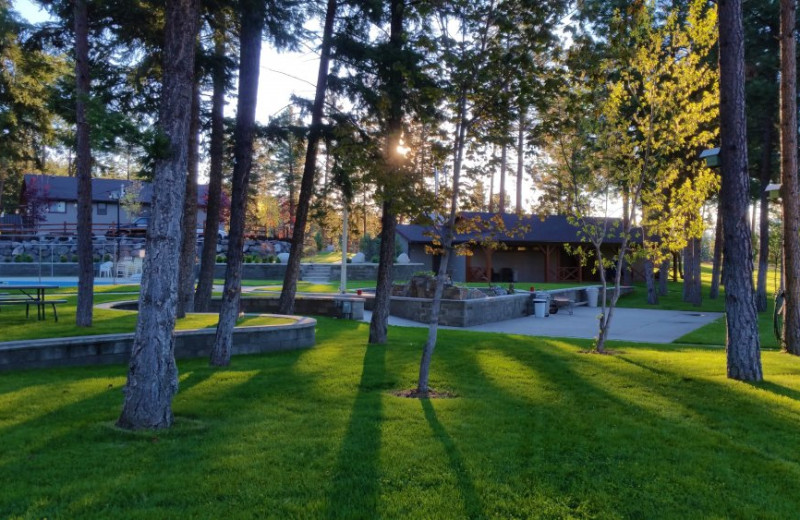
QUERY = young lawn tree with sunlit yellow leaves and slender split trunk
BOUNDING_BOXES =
[572,1,716,352]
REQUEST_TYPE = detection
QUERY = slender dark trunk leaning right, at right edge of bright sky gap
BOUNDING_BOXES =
[278,0,338,314]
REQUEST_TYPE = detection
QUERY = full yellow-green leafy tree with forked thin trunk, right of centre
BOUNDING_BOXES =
[549,1,717,351]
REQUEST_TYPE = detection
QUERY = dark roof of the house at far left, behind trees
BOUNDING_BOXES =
[23,173,208,207]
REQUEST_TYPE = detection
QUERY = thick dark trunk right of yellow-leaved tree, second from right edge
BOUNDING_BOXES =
[718,0,763,381]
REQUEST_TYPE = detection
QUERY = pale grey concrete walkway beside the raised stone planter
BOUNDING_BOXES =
[364,307,722,343]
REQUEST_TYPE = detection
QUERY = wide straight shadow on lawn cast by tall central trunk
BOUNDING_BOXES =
[326,345,386,518]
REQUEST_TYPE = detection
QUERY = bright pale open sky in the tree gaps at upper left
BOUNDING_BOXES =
[13,0,319,124]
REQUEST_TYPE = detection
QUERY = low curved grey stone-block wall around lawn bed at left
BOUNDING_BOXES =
[0,302,317,371]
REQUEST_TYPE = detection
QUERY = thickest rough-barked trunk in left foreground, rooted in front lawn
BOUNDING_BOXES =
[117,0,199,430]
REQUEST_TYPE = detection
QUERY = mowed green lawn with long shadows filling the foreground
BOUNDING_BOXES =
[0,318,800,519]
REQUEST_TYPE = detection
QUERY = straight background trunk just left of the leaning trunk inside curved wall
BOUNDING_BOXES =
[194,12,226,312]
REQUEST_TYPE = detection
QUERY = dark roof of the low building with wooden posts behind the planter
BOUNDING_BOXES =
[397,212,641,244]
